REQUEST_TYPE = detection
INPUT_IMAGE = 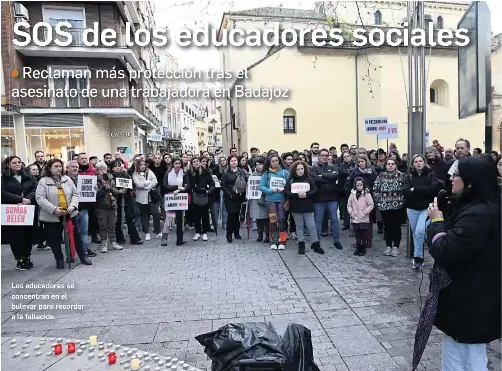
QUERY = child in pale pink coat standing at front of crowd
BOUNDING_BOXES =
[347,177,373,256]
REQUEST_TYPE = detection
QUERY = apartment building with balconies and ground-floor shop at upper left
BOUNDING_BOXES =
[1,1,165,162]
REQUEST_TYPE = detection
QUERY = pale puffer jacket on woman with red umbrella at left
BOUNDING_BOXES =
[35,175,79,223]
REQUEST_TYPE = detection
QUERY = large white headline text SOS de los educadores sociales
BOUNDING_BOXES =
[12,22,469,47]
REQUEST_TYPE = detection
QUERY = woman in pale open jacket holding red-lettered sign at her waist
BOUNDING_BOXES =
[160,158,186,246]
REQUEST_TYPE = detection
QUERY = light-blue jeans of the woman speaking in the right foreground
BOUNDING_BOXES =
[442,335,488,371]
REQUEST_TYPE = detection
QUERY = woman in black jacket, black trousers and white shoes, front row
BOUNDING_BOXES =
[186,157,214,241]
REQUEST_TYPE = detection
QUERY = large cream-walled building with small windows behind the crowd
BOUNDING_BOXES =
[220,1,498,152]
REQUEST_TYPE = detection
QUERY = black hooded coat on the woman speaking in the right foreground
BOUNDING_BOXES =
[427,201,502,344]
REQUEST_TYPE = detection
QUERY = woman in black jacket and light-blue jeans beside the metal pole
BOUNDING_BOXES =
[403,155,439,269]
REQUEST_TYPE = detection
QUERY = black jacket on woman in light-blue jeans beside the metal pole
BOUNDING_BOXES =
[403,167,439,210]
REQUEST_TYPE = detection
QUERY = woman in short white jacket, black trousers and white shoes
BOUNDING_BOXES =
[132,158,162,241]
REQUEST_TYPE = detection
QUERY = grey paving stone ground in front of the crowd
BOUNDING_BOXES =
[2,227,501,371]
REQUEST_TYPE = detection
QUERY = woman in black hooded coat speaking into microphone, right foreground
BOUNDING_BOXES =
[424,156,502,371]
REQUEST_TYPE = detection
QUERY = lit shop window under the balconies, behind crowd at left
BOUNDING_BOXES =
[26,127,85,162]
